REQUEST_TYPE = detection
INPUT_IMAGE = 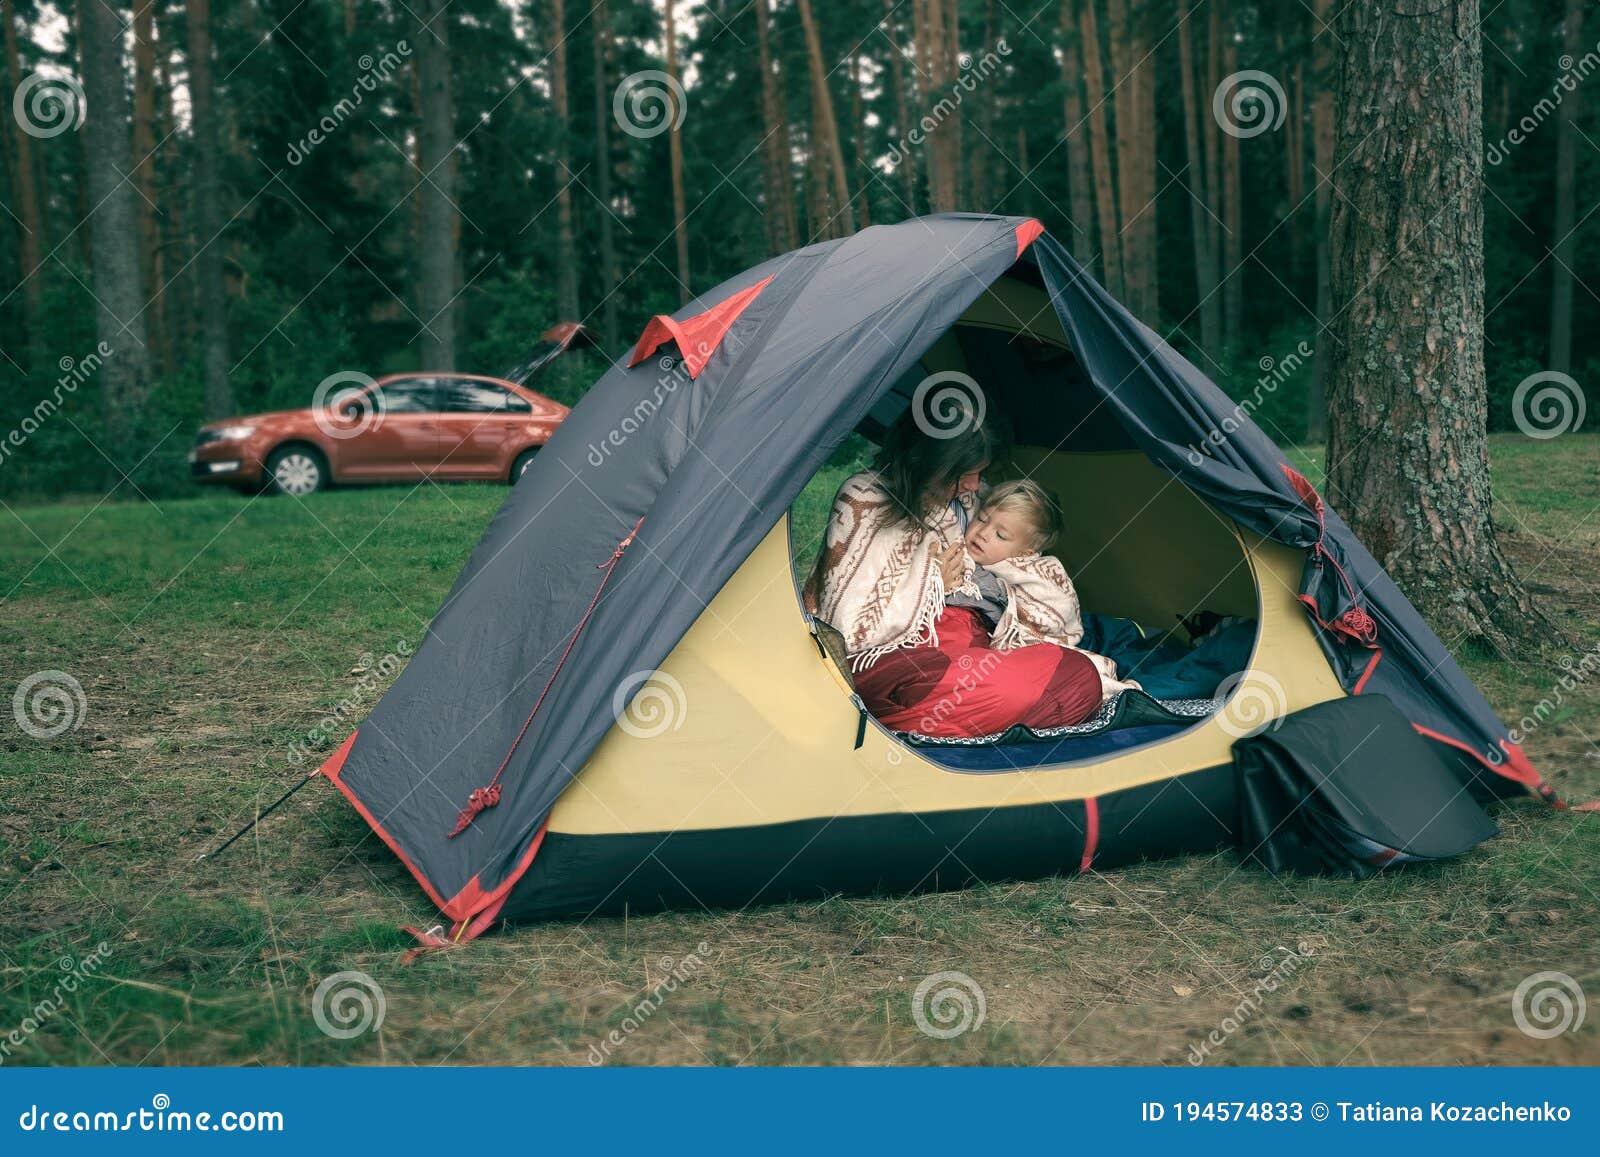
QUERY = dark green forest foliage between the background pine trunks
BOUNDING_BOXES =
[0,0,1600,496]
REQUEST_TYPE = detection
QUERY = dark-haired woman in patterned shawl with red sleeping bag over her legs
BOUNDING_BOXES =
[805,405,1104,738]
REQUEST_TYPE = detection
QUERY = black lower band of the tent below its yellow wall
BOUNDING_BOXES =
[501,765,1238,922]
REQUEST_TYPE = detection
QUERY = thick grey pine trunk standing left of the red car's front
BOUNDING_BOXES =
[80,0,150,457]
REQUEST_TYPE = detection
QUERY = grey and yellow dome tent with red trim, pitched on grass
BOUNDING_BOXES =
[323,214,1549,939]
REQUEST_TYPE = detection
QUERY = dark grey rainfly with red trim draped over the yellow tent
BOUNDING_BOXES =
[323,213,1549,938]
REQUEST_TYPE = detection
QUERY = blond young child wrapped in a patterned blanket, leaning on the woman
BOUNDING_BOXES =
[946,478,1139,699]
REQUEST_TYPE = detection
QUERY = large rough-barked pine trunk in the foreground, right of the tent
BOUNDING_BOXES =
[1328,0,1550,658]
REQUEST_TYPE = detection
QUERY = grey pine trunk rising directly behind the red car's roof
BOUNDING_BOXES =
[416,0,456,371]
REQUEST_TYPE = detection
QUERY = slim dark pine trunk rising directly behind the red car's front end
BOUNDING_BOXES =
[186,0,235,419]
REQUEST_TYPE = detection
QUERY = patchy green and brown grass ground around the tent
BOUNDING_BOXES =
[0,437,1600,1064]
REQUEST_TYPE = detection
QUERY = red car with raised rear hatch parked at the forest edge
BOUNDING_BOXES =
[189,323,595,496]
